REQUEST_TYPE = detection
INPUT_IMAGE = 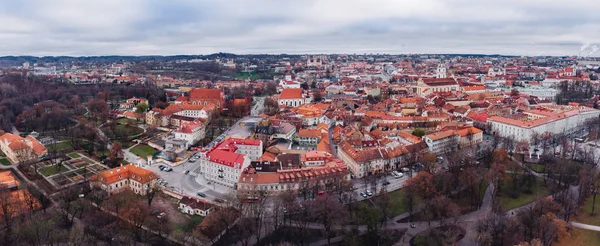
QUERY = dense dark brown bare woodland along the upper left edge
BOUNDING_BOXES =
[0,72,165,132]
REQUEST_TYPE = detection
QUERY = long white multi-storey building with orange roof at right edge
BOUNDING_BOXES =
[488,106,600,141]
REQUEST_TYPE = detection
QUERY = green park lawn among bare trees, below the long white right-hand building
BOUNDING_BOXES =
[498,178,550,211]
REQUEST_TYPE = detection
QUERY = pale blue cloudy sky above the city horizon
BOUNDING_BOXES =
[0,0,600,56]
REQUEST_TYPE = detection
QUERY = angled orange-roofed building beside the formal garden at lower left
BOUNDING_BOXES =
[90,164,157,195]
